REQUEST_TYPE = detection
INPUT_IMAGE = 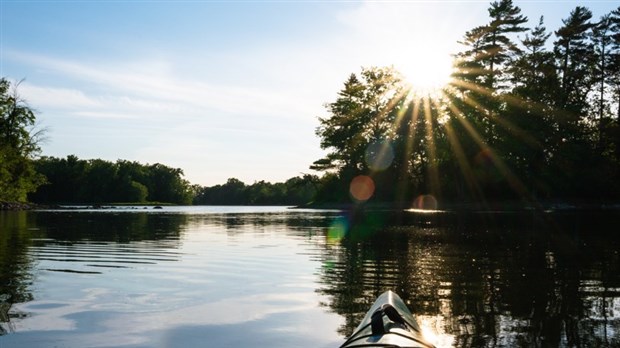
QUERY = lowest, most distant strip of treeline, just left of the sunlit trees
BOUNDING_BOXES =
[194,175,319,205]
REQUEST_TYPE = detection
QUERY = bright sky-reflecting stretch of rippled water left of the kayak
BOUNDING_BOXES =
[0,208,341,348]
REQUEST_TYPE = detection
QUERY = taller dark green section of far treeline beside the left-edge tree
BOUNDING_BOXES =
[29,155,193,204]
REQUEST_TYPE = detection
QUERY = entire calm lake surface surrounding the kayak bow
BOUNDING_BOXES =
[0,207,620,348]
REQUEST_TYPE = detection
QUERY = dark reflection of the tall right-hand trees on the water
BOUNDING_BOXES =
[319,214,620,347]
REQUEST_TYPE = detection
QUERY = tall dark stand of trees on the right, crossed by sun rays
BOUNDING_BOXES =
[311,0,620,205]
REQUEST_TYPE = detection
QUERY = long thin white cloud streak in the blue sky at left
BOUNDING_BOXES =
[8,52,318,123]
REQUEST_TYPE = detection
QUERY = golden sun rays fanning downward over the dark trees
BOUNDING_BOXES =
[376,58,541,205]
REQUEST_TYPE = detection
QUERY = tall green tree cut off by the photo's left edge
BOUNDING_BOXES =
[0,78,44,202]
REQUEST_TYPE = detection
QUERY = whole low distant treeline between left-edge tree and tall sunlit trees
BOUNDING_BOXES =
[28,155,319,205]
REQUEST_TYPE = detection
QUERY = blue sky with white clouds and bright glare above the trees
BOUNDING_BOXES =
[0,0,618,186]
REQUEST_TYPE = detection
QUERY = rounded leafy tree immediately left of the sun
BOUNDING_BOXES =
[311,68,405,204]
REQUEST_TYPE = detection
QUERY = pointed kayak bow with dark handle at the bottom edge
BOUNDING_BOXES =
[340,290,435,348]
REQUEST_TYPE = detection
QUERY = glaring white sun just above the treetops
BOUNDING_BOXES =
[395,52,453,96]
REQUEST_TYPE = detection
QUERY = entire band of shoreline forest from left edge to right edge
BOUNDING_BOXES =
[0,0,620,206]
